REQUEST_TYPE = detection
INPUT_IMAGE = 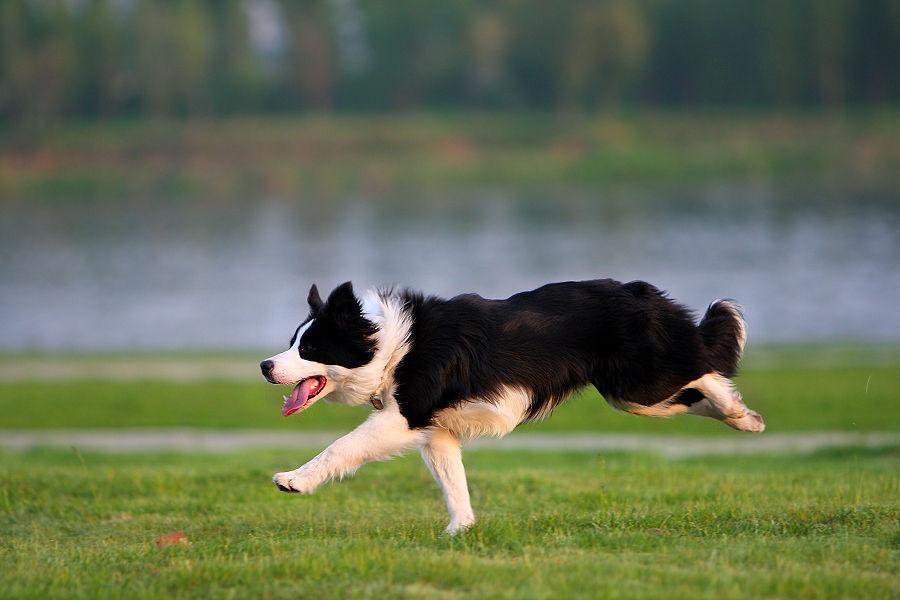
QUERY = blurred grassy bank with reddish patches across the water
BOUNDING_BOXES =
[0,111,900,198]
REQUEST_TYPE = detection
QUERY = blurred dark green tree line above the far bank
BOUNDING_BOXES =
[0,0,900,120]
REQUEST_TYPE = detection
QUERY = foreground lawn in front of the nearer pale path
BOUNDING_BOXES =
[0,449,900,598]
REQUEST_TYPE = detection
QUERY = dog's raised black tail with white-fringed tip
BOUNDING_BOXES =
[700,300,747,377]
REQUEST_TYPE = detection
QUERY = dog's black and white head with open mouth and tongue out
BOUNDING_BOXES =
[259,281,378,417]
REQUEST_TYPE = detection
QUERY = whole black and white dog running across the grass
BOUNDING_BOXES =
[260,279,765,534]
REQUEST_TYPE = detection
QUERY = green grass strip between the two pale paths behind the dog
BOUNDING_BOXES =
[0,366,900,435]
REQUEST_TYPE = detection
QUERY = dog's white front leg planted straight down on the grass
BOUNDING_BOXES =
[421,429,475,535]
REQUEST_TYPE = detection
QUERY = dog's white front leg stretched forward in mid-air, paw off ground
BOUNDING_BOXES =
[272,403,426,494]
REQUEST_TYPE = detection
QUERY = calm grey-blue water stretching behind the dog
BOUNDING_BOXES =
[0,184,900,350]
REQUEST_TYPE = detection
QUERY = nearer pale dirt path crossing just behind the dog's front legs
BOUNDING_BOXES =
[0,429,900,458]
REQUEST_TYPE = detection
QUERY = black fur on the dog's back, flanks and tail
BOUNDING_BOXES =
[395,279,740,427]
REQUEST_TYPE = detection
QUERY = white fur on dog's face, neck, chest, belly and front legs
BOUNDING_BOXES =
[269,291,492,535]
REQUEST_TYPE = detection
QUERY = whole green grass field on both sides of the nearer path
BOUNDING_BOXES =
[0,347,900,599]
